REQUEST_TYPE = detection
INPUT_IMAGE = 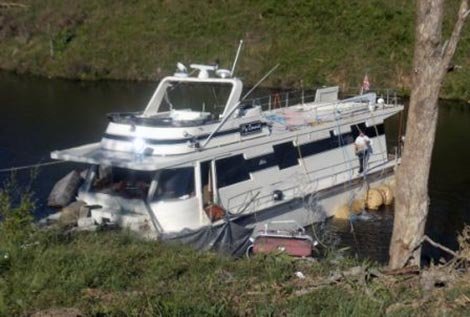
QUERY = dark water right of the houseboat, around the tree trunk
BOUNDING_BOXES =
[327,100,470,262]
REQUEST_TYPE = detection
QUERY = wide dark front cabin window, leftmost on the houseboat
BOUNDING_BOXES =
[91,166,153,199]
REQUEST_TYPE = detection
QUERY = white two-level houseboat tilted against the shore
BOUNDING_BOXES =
[51,53,403,237]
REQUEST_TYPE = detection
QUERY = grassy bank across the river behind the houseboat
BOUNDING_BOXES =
[0,0,470,100]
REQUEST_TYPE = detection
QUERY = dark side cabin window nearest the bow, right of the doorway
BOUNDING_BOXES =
[215,154,250,188]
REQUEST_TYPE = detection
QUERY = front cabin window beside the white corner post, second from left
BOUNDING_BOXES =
[153,167,195,201]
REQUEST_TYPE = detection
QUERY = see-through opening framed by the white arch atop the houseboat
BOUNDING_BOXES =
[159,81,232,117]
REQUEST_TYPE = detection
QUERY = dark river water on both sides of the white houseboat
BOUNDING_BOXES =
[0,72,470,262]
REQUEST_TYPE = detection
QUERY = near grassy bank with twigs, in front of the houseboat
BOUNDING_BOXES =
[0,187,470,316]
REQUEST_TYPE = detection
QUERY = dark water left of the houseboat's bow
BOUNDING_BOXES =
[0,72,156,213]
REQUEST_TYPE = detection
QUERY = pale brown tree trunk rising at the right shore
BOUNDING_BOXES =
[389,0,469,269]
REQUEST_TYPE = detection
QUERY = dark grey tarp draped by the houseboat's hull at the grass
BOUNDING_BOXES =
[161,221,253,256]
